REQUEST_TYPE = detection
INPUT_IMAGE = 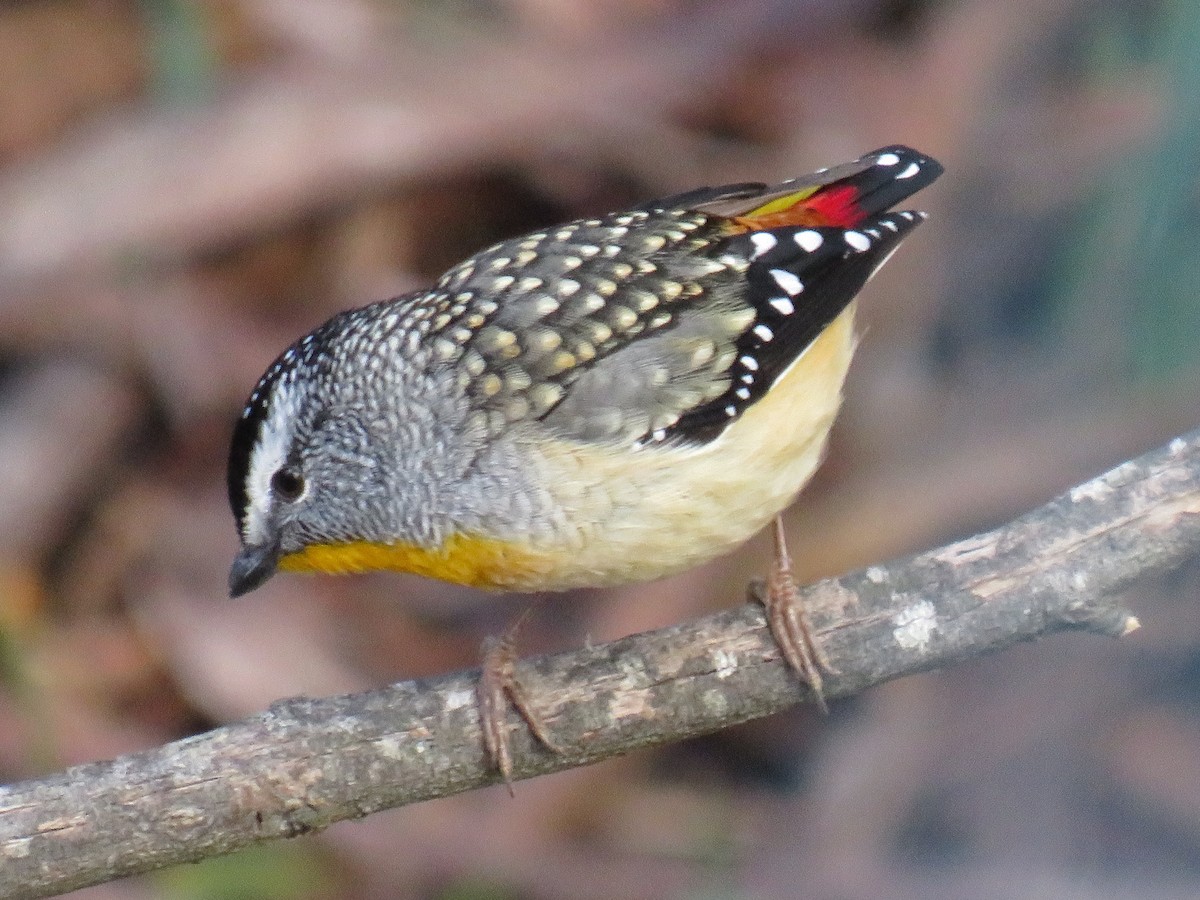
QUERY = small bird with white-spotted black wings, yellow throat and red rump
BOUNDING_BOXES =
[228,145,942,780]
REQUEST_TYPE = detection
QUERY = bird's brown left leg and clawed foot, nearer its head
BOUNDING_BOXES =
[479,606,562,796]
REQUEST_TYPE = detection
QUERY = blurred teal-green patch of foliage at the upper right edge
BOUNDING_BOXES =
[1063,0,1200,380]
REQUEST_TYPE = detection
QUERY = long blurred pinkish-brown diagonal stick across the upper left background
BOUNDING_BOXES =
[0,0,874,285]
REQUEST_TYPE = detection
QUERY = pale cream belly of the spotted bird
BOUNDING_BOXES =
[520,304,854,590]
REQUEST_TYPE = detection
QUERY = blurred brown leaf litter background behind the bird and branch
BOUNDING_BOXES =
[0,0,1200,900]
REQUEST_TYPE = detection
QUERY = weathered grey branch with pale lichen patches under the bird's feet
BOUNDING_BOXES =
[0,431,1200,898]
